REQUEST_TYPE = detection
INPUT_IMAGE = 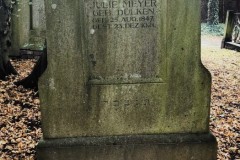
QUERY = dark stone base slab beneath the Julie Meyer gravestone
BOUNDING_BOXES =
[37,134,217,160]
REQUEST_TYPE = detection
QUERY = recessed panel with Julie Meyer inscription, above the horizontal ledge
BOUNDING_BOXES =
[85,0,166,84]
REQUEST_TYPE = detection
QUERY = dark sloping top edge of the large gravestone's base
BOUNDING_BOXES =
[37,133,217,149]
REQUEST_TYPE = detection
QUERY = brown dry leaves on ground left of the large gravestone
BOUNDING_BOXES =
[0,60,42,160]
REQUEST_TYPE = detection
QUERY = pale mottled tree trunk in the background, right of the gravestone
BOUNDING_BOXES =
[208,0,219,25]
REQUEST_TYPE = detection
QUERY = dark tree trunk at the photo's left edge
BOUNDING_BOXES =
[0,0,17,80]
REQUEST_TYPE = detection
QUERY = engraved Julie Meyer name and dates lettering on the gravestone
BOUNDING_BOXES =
[90,0,157,29]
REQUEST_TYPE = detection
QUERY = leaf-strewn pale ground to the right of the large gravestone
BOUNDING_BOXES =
[202,48,240,160]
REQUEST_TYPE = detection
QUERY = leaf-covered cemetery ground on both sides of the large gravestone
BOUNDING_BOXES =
[0,35,240,160]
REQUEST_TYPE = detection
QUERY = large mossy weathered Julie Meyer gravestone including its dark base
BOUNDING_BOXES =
[37,0,216,160]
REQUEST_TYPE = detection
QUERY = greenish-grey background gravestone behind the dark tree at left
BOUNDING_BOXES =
[10,0,46,57]
